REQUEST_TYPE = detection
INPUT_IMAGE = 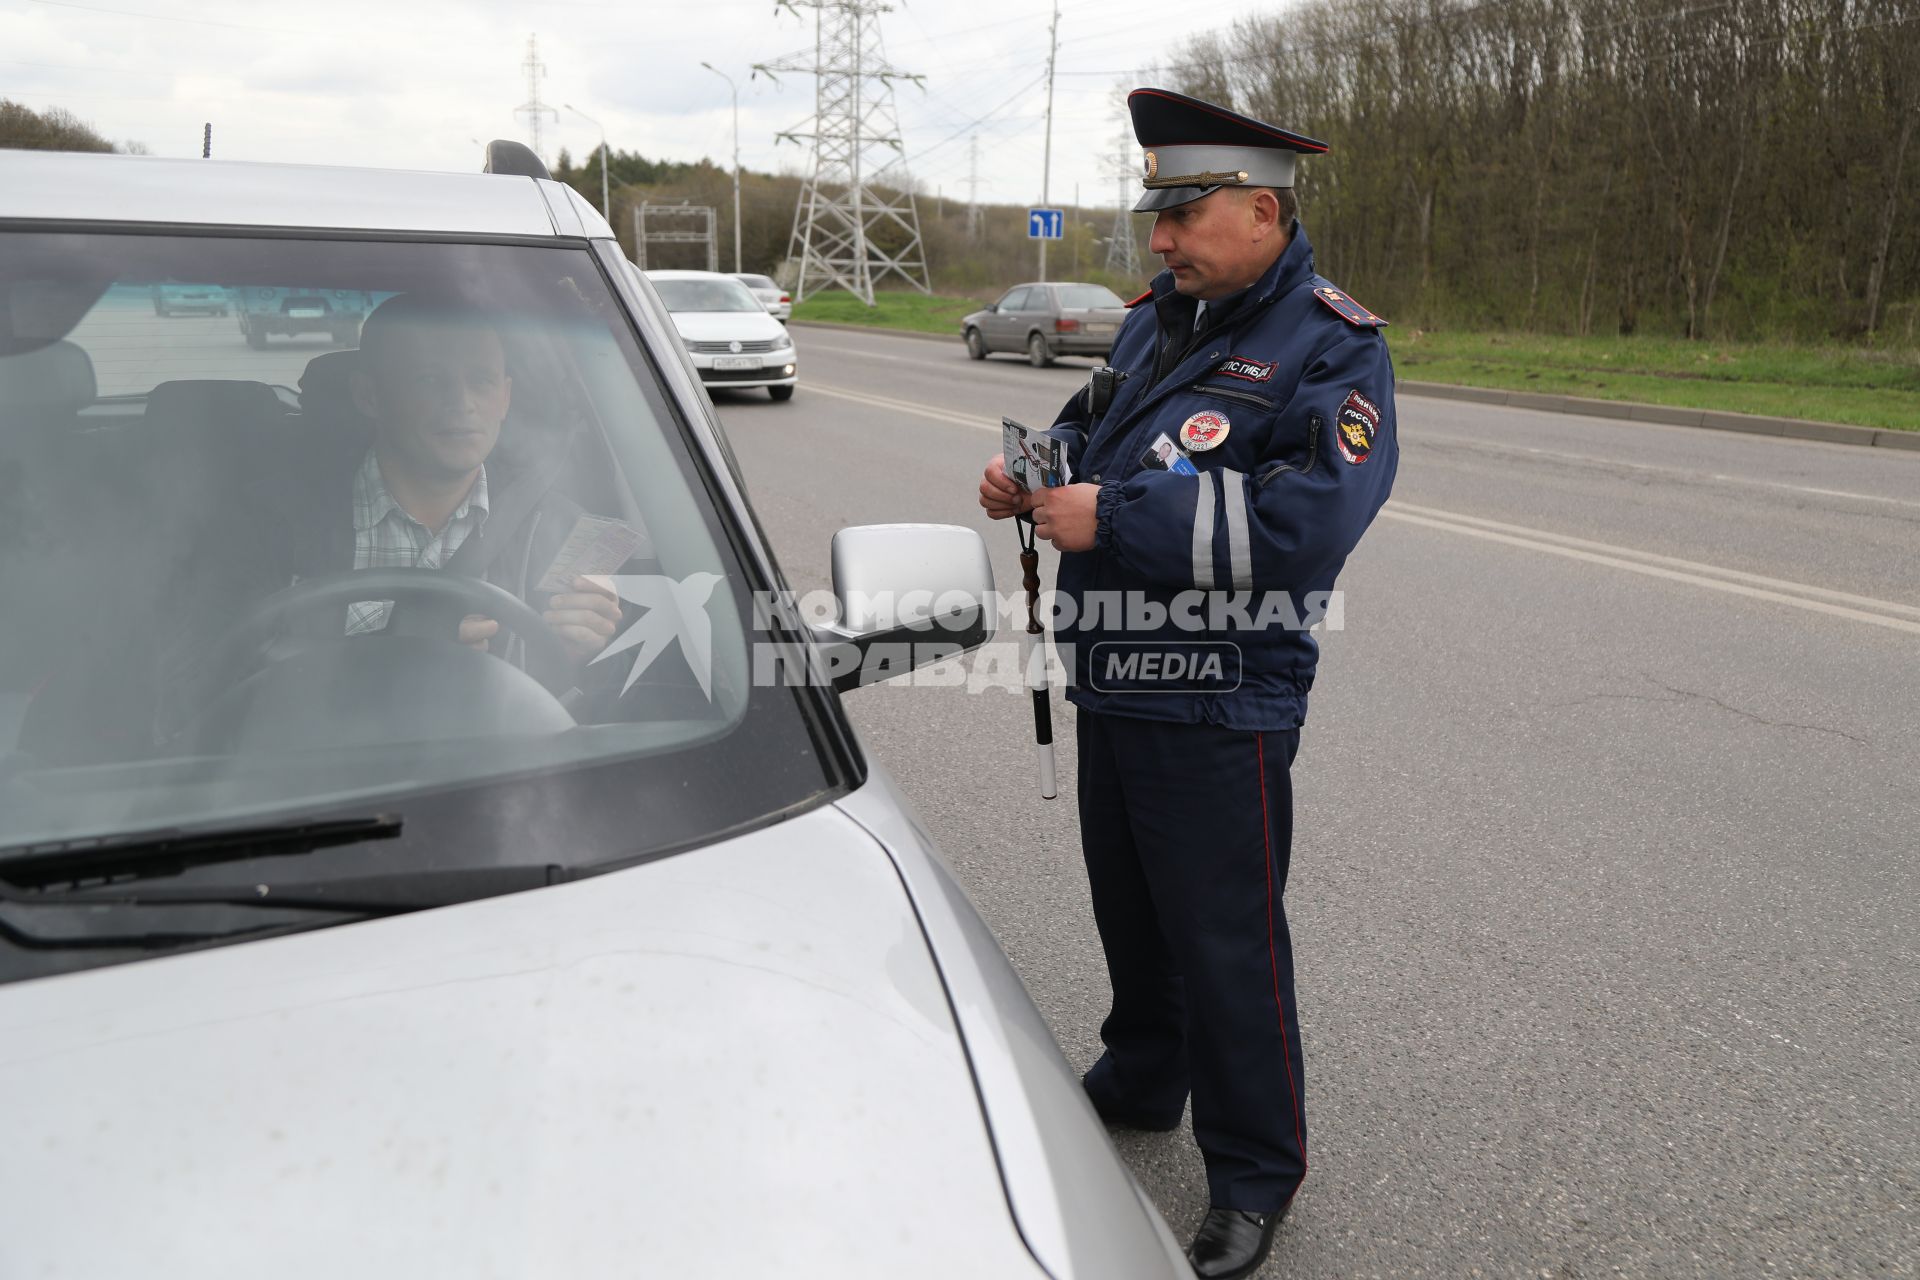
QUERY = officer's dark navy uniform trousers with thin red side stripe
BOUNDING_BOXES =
[1077,710,1308,1213]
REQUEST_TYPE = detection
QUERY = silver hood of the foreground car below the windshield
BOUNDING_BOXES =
[0,808,1035,1276]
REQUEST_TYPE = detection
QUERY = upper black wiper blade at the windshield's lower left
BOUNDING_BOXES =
[0,814,401,887]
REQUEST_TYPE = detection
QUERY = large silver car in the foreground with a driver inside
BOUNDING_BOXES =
[0,144,1190,1280]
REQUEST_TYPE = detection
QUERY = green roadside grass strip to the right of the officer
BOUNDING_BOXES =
[1386,328,1920,432]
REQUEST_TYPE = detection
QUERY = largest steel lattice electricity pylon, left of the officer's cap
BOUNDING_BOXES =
[753,0,933,307]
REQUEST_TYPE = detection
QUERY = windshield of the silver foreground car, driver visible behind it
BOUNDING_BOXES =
[0,228,829,890]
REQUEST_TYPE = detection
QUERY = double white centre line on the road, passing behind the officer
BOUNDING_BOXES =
[808,382,1920,635]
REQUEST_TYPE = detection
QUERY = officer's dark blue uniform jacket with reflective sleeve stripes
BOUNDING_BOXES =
[1052,223,1400,731]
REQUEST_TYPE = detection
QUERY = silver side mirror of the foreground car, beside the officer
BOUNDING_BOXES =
[812,524,993,693]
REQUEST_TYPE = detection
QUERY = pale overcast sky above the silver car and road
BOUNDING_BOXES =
[0,0,1286,207]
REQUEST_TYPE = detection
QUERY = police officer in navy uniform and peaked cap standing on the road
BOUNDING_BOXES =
[979,88,1400,1276]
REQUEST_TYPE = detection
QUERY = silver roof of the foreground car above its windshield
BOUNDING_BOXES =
[0,150,612,238]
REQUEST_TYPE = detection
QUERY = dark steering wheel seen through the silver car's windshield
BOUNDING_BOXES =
[207,568,572,693]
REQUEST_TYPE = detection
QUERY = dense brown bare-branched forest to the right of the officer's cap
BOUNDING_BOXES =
[1167,0,1920,345]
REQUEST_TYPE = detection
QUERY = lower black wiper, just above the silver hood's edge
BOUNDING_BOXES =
[22,865,572,915]
